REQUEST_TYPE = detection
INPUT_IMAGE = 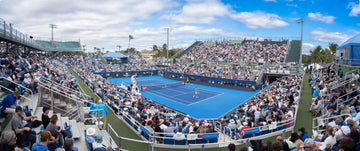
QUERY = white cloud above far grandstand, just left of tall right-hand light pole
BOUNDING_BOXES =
[230,11,289,29]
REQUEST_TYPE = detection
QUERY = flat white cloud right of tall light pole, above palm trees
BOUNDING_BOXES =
[311,30,351,43]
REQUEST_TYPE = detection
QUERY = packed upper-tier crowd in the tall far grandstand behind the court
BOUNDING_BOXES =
[181,40,286,63]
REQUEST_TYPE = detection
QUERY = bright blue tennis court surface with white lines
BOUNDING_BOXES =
[108,76,258,119]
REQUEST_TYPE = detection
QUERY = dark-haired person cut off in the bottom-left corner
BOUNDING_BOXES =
[0,130,20,151]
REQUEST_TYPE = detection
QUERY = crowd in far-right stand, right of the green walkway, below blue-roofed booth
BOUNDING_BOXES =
[309,65,360,151]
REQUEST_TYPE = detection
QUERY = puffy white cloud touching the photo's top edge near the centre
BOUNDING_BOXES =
[163,0,230,24]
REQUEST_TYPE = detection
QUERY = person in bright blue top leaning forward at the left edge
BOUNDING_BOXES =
[0,90,20,117]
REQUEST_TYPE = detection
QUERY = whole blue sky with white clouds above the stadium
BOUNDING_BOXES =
[0,0,360,53]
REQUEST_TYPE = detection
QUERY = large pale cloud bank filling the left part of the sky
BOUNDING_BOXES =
[0,0,174,49]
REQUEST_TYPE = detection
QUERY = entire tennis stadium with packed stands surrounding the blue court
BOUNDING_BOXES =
[0,15,360,151]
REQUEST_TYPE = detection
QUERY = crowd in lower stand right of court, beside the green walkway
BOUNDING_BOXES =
[219,75,302,138]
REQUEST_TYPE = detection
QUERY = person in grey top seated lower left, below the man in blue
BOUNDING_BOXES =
[11,106,36,148]
